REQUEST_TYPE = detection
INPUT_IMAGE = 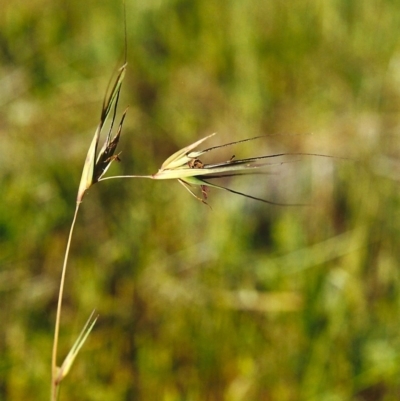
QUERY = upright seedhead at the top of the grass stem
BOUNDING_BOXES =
[76,64,127,203]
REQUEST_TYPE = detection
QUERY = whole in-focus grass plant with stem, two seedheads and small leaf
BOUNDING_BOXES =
[51,56,344,401]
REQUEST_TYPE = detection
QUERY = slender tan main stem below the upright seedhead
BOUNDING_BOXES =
[50,202,81,401]
